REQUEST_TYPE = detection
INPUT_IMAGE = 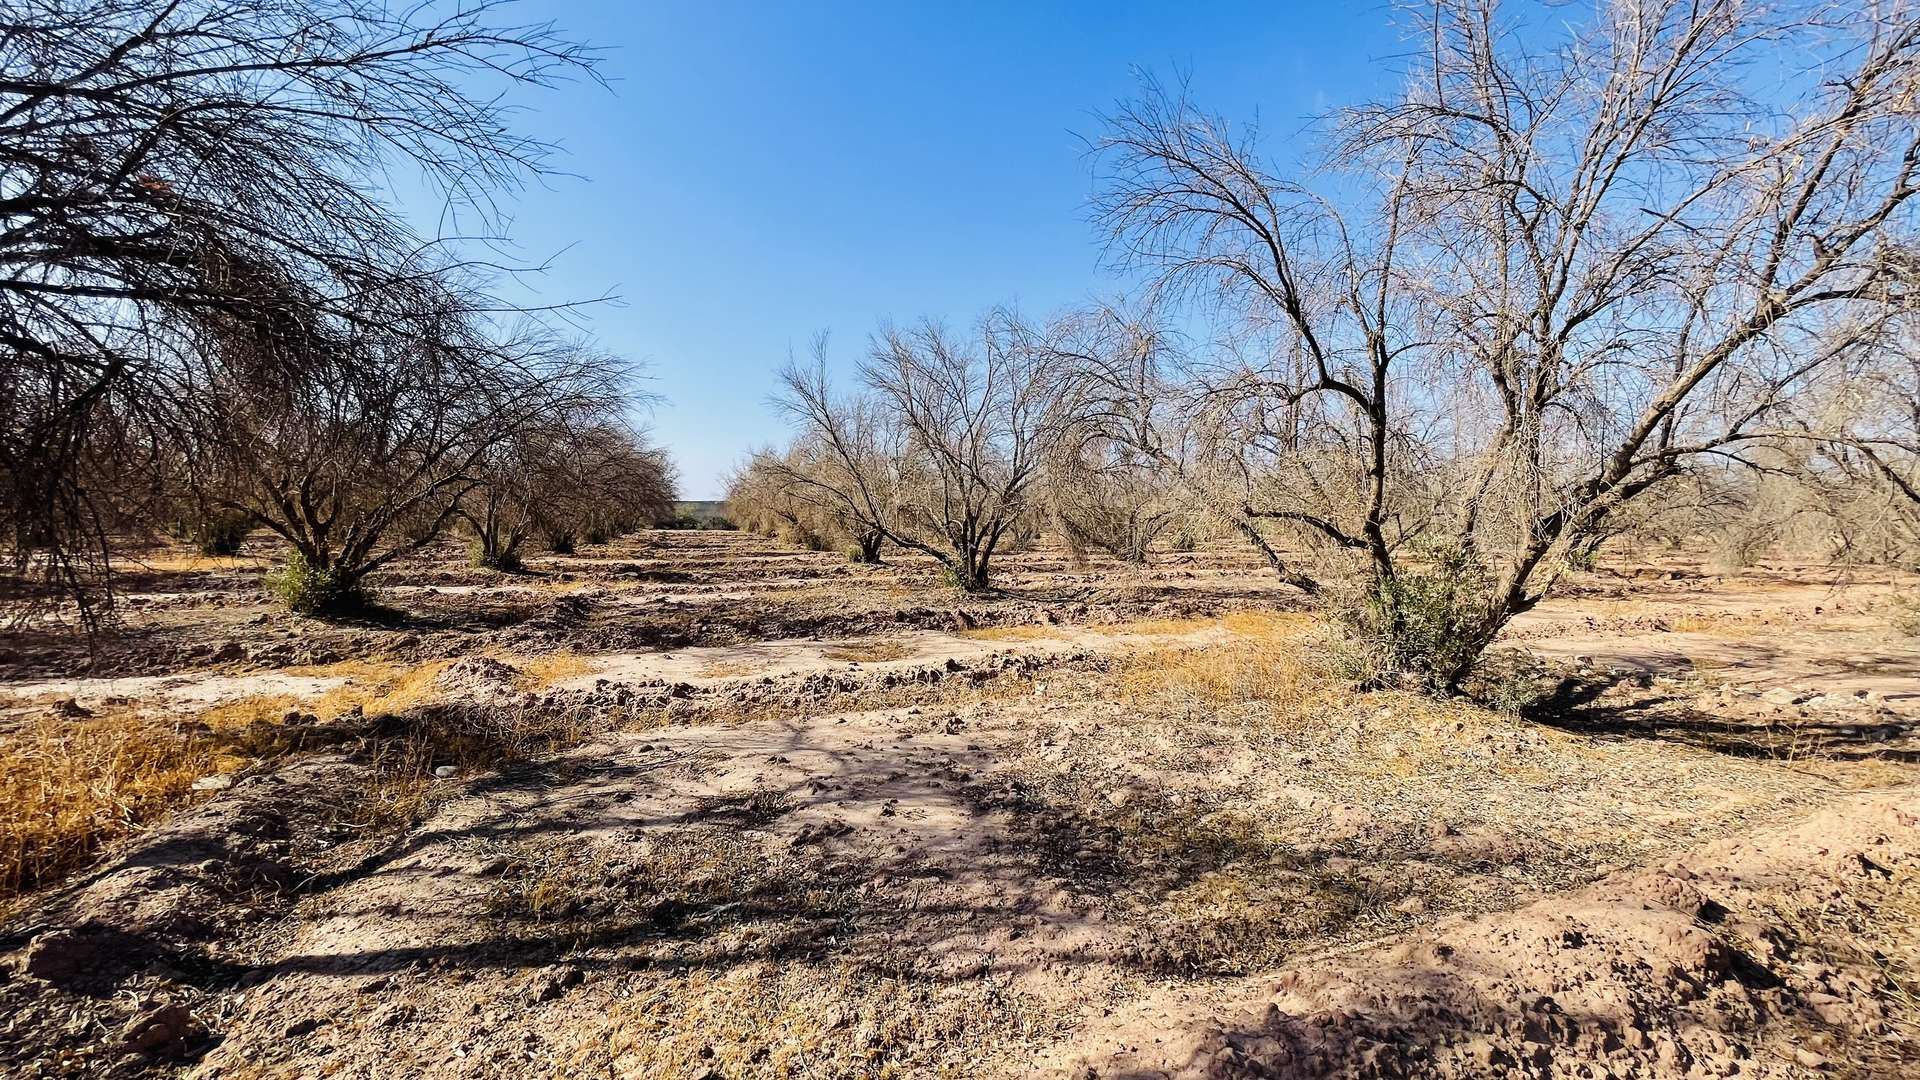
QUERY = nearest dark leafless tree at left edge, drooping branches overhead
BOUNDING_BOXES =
[0,0,591,611]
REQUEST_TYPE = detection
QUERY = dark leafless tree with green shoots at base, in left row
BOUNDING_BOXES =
[175,278,626,611]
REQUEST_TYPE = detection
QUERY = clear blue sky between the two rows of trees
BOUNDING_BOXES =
[483,0,1404,498]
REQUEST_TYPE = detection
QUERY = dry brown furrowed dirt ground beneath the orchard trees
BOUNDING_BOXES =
[0,532,1920,1080]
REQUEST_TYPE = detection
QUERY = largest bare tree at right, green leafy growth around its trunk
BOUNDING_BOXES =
[1098,0,1920,686]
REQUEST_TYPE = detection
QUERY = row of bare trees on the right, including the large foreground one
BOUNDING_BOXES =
[743,0,1920,686]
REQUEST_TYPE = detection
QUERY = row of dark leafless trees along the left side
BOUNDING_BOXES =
[0,0,672,619]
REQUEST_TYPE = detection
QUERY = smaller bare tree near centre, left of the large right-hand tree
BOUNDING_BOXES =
[780,311,1069,592]
